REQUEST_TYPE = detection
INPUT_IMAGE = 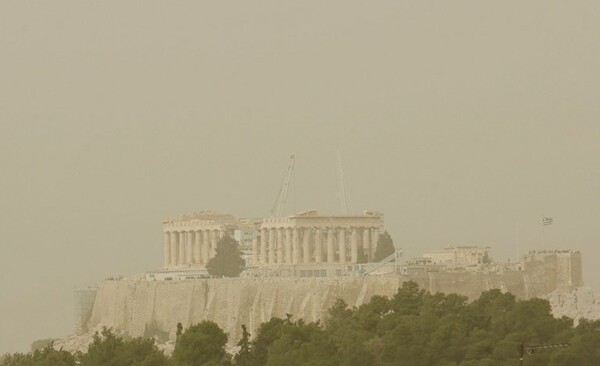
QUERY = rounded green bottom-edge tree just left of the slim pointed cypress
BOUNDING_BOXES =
[172,320,230,366]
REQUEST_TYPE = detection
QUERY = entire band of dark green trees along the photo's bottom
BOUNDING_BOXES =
[0,282,600,366]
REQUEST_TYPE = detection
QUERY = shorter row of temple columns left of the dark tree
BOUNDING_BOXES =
[163,230,225,268]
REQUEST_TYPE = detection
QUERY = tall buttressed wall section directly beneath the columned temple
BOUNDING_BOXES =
[89,277,401,341]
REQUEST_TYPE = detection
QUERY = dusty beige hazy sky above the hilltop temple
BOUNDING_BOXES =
[0,0,600,353]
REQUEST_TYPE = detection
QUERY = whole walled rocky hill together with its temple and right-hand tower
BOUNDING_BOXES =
[64,211,583,350]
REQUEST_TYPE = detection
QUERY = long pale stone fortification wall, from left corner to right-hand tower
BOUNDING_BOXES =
[88,253,582,342]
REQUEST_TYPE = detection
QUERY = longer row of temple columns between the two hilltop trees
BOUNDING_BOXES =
[252,227,379,265]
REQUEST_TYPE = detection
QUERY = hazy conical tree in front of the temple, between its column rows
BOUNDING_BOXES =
[206,235,246,277]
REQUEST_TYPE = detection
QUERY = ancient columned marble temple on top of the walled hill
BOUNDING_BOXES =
[163,210,383,269]
